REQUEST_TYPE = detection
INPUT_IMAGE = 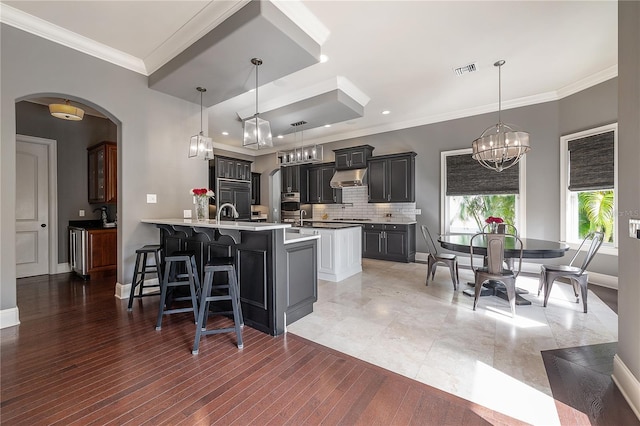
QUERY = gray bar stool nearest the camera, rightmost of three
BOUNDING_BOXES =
[191,257,244,355]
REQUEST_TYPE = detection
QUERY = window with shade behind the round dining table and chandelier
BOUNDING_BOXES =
[440,149,525,235]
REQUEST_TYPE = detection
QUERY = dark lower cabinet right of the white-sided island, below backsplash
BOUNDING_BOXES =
[362,223,416,262]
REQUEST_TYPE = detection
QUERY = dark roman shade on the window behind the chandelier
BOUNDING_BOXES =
[446,154,520,196]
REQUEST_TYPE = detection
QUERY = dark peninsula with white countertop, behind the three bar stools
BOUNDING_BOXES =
[142,219,320,336]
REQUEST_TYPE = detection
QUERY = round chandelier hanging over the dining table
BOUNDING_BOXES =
[471,60,531,172]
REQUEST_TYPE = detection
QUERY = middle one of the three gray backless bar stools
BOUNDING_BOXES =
[156,251,200,330]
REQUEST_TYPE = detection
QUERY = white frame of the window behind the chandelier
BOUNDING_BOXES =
[440,148,527,238]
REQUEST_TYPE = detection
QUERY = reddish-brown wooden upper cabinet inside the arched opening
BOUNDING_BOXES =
[87,142,118,204]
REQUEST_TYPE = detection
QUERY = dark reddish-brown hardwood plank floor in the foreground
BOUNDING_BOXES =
[0,274,528,425]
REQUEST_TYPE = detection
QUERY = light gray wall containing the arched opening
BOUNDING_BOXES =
[0,24,208,310]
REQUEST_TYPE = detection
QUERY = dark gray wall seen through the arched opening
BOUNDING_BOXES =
[16,101,117,263]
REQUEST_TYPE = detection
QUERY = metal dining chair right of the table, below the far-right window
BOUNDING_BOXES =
[538,232,604,314]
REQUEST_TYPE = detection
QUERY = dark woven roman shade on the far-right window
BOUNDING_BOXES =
[567,131,615,191]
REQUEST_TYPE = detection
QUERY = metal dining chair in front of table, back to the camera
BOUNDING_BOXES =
[469,232,522,317]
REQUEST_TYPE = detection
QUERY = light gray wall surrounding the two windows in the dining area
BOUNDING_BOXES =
[255,78,618,276]
